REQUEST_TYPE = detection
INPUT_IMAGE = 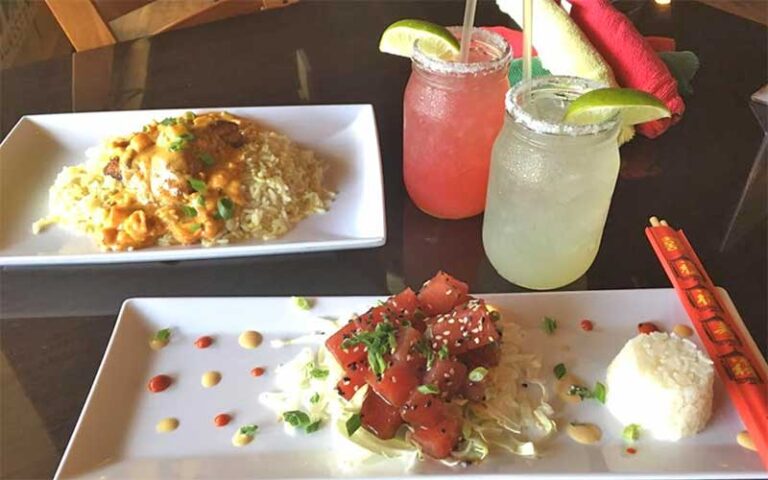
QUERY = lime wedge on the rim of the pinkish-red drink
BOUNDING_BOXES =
[379,20,460,59]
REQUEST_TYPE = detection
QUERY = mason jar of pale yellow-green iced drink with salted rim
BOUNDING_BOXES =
[483,77,619,290]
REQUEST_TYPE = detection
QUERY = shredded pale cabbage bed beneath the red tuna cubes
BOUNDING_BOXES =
[260,310,557,470]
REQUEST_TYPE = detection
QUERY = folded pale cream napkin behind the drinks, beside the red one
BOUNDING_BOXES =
[496,0,632,143]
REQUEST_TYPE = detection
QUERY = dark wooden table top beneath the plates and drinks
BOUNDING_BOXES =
[0,1,768,478]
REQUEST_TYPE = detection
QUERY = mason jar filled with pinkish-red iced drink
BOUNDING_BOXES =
[403,27,511,218]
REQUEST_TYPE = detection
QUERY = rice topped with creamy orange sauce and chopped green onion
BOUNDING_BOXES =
[33,112,333,251]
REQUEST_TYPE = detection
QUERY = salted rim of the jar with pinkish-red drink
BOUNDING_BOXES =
[411,27,512,75]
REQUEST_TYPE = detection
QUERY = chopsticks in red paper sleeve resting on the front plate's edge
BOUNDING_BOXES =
[645,217,768,469]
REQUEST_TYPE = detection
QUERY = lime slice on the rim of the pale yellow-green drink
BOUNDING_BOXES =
[564,88,671,125]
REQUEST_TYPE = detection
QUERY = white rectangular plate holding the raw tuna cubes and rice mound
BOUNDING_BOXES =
[56,289,765,479]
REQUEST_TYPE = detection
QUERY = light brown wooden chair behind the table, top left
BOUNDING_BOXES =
[45,0,298,52]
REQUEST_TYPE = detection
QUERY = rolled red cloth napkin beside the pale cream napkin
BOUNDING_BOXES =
[569,0,685,138]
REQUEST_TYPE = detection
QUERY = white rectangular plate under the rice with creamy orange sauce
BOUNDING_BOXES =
[0,105,385,265]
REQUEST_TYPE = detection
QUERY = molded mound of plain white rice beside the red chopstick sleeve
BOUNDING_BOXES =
[606,332,714,441]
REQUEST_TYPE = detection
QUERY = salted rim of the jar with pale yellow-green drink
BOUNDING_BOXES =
[505,75,619,137]
